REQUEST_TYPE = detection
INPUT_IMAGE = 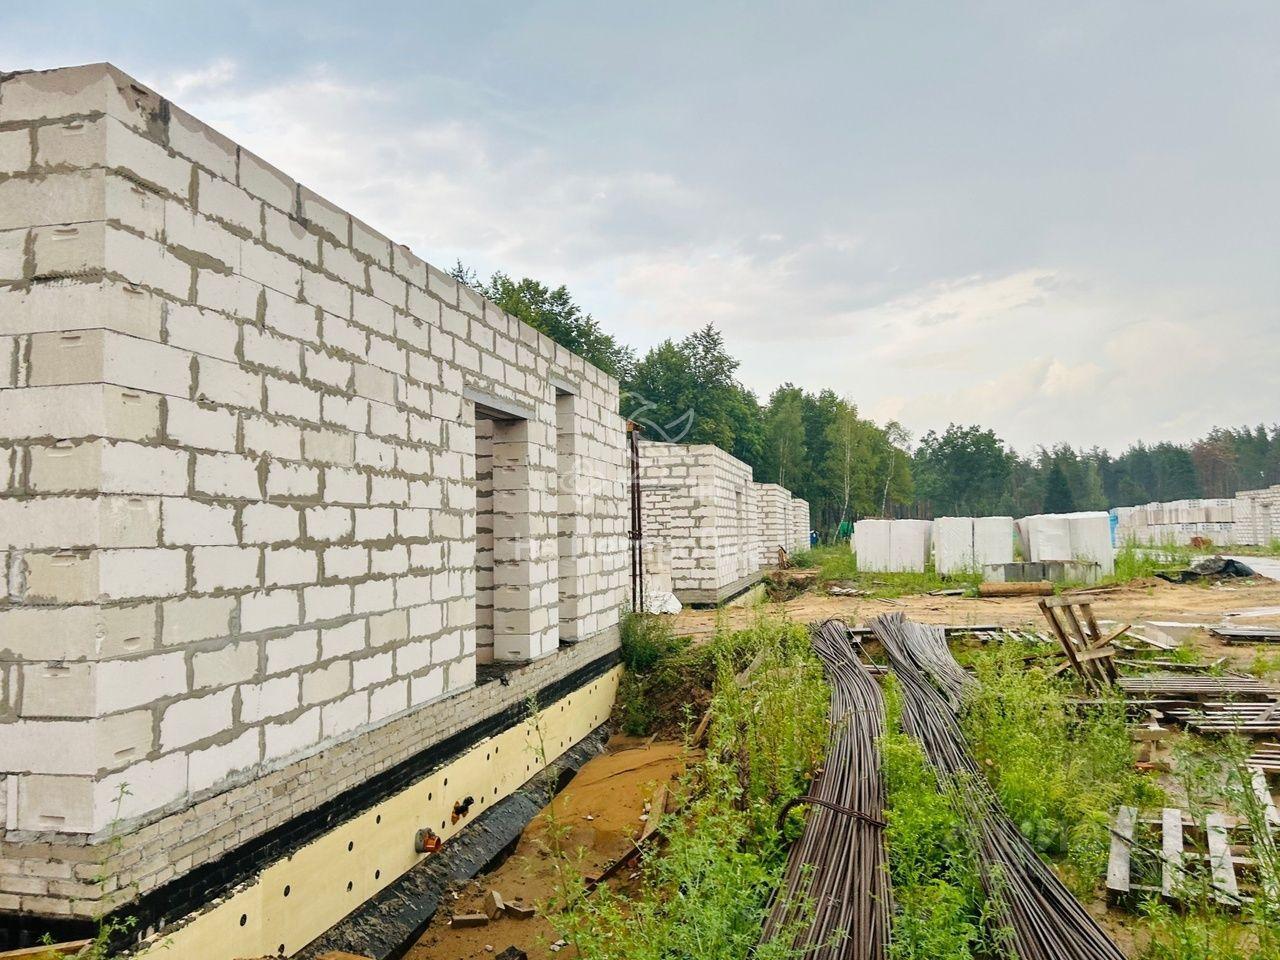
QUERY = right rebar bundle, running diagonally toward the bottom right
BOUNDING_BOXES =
[870,613,1124,960]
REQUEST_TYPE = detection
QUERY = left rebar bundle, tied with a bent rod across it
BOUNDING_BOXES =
[764,621,893,960]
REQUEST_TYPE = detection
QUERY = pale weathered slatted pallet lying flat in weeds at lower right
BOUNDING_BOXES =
[1107,803,1276,908]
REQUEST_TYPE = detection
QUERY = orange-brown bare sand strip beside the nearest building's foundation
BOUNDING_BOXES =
[406,736,686,960]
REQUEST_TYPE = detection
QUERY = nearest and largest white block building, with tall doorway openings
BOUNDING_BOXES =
[0,64,629,957]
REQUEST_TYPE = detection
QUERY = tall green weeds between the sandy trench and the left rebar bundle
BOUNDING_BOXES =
[549,620,828,960]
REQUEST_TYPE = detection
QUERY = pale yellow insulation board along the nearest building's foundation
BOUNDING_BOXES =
[136,667,622,960]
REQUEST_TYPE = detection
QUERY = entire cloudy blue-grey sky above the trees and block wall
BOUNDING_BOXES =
[0,0,1280,451]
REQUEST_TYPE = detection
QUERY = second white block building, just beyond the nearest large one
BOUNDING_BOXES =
[640,440,757,604]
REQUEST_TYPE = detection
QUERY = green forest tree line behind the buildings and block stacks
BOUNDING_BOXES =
[453,264,1280,535]
